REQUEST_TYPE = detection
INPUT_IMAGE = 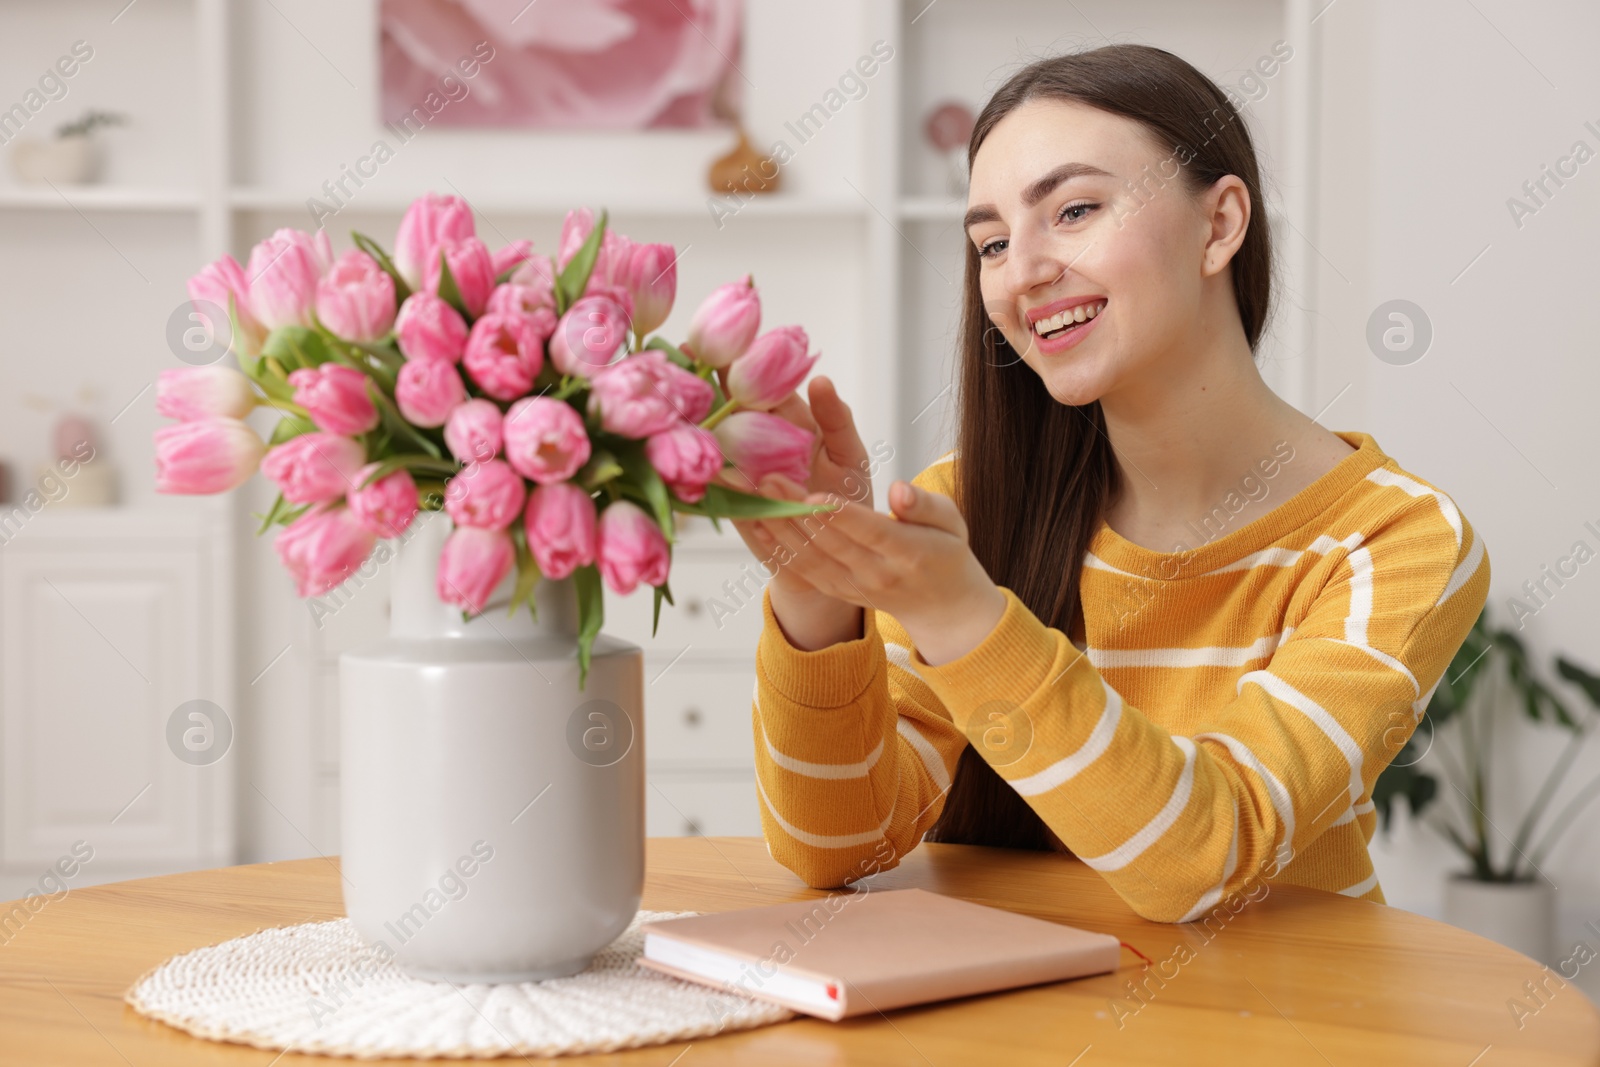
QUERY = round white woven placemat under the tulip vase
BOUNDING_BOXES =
[125,912,794,1059]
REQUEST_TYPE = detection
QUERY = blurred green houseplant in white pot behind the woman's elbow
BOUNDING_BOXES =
[1373,608,1600,961]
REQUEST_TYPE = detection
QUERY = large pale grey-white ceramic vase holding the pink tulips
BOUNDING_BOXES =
[339,512,645,982]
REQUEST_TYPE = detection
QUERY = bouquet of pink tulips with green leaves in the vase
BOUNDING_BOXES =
[155,194,826,683]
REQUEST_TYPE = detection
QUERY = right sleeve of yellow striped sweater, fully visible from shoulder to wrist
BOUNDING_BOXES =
[910,494,1490,921]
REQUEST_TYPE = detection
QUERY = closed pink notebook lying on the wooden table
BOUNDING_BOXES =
[638,889,1120,1019]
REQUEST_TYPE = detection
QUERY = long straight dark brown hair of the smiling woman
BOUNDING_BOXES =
[926,45,1272,849]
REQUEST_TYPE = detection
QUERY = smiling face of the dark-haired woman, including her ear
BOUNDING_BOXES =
[966,99,1248,405]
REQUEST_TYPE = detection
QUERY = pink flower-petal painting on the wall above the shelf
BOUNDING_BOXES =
[379,0,747,130]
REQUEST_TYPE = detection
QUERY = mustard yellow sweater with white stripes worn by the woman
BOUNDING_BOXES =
[752,432,1490,921]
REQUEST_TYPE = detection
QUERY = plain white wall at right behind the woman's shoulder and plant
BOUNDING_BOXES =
[1317,0,1600,945]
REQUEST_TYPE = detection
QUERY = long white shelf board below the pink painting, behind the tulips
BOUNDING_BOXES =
[229,186,869,219]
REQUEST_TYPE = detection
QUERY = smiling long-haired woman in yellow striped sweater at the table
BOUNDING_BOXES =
[723,45,1490,921]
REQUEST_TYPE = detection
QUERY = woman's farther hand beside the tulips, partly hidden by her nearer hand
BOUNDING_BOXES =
[717,374,872,651]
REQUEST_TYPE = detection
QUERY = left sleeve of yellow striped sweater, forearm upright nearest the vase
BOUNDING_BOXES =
[752,467,966,888]
